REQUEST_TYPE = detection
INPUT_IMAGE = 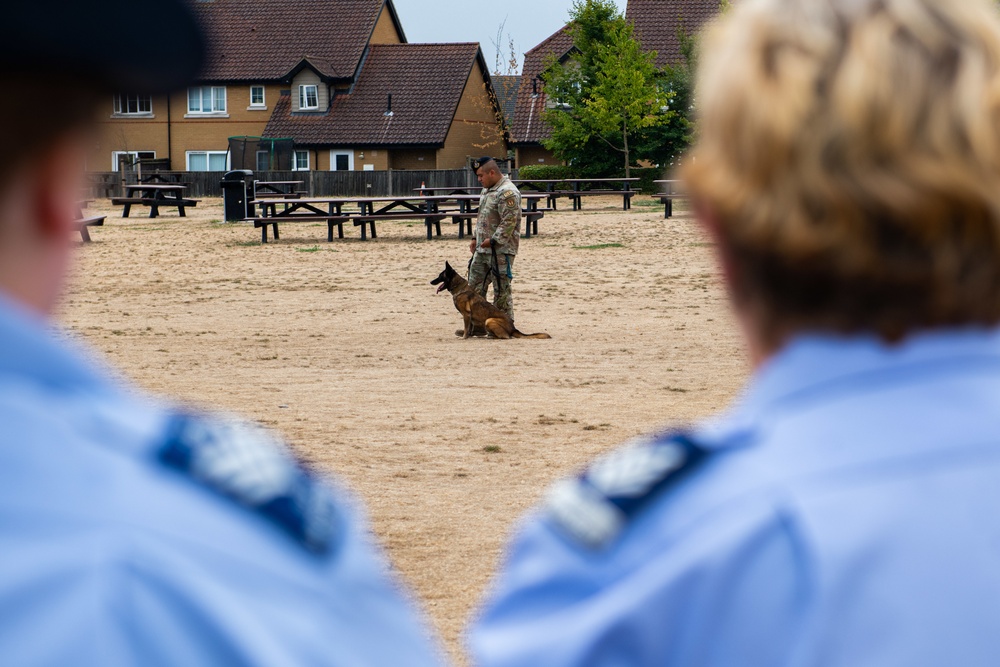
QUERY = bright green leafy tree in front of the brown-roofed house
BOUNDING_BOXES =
[543,0,676,177]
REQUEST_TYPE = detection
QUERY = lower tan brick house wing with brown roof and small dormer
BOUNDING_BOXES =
[264,43,507,171]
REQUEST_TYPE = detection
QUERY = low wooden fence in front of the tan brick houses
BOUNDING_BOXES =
[90,169,492,197]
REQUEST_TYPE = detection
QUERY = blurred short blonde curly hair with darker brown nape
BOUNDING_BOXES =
[683,0,1000,346]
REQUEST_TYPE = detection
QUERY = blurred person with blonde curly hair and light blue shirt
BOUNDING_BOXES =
[469,0,1000,667]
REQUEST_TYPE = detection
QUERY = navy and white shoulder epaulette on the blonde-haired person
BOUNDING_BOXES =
[545,433,707,549]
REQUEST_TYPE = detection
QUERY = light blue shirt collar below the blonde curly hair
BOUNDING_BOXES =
[695,327,1000,446]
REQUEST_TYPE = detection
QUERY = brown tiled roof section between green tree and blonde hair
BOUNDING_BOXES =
[625,0,719,67]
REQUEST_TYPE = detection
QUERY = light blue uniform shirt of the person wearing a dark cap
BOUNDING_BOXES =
[0,298,440,667]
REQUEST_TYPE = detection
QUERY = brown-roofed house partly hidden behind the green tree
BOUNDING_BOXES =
[510,0,719,166]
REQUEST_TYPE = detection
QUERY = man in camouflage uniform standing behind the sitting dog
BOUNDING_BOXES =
[455,157,521,336]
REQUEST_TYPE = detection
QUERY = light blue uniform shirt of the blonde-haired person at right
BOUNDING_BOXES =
[468,330,1000,667]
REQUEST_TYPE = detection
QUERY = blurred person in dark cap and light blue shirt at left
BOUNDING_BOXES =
[0,0,438,667]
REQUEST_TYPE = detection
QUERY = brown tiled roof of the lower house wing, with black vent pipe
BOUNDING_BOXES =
[264,43,486,146]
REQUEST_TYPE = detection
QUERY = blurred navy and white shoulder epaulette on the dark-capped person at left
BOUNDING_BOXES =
[158,413,336,554]
